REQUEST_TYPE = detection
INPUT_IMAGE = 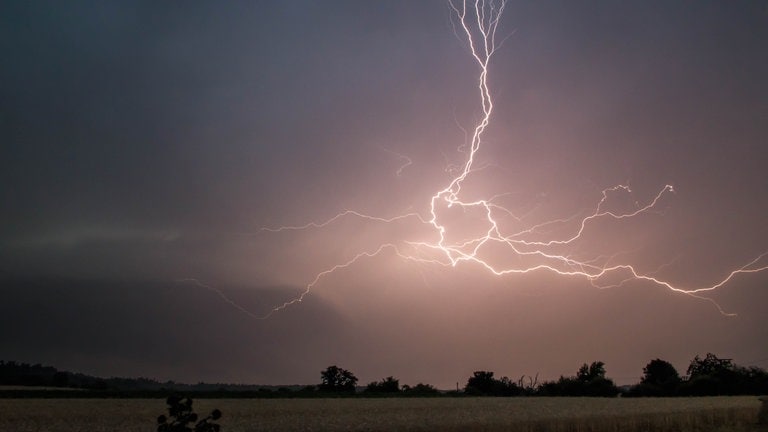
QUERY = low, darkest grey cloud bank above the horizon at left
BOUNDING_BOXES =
[0,278,351,384]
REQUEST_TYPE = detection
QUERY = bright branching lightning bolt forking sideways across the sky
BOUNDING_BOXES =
[186,0,768,319]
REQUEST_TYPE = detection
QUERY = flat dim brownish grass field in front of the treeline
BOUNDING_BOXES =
[0,396,768,432]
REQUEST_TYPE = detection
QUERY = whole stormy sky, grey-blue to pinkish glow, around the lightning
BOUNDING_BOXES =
[0,1,768,388]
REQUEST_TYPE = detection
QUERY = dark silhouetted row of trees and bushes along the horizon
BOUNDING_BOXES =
[0,353,768,398]
